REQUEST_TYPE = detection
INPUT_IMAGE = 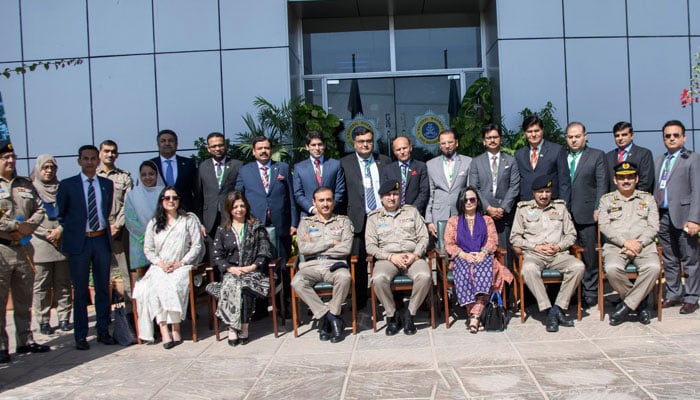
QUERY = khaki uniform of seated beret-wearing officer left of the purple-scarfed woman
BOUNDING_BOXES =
[365,205,433,317]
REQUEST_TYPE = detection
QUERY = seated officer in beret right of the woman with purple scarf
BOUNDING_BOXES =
[510,175,585,332]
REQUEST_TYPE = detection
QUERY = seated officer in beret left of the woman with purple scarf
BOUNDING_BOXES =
[365,180,433,336]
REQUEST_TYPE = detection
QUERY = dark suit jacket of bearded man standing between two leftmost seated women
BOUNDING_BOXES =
[195,159,243,238]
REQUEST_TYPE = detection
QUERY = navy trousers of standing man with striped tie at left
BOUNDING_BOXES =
[68,234,112,341]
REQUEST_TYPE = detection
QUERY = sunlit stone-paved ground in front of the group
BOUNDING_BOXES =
[0,290,700,399]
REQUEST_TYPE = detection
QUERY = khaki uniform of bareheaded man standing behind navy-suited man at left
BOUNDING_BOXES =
[97,165,133,304]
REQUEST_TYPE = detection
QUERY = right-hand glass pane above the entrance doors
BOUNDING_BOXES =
[394,14,481,71]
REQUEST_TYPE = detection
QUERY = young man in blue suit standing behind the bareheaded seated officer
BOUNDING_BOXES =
[292,131,345,217]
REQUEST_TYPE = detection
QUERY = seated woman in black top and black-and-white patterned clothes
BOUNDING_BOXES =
[207,191,272,346]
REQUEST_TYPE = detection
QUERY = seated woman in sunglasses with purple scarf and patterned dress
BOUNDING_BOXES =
[444,187,513,333]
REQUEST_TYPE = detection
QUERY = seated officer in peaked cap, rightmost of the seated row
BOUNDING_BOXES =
[598,162,661,326]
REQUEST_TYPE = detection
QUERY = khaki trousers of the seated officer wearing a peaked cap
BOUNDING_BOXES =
[603,243,661,310]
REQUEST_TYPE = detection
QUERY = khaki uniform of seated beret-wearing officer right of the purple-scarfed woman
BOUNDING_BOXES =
[510,200,585,311]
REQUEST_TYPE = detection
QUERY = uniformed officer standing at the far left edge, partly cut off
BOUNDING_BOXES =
[0,140,51,363]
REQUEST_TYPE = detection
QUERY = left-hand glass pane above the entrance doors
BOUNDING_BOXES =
[302,17,391,75]
